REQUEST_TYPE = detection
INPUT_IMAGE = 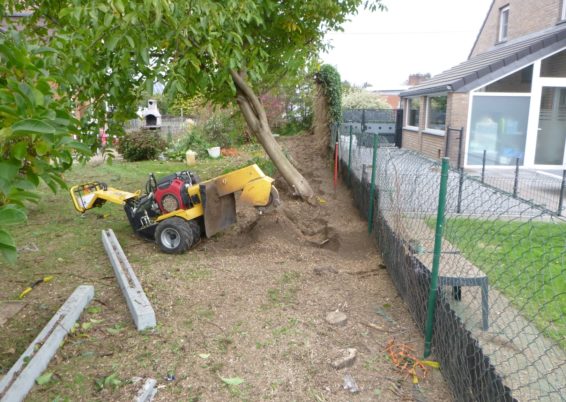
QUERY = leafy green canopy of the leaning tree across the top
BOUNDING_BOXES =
[3,0,381,127]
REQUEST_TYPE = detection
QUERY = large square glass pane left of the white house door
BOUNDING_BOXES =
[468,96,530,166]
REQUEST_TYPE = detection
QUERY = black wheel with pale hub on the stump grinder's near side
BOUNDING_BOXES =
[155,217,194,254]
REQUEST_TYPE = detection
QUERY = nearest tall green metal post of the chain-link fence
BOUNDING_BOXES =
[424,158,449,358]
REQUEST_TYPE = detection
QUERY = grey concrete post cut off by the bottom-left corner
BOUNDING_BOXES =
[0,285,94,402]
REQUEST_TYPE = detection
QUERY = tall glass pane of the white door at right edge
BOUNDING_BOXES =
[535,87,566,166]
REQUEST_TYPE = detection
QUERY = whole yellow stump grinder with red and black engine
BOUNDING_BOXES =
[70,165,279,254]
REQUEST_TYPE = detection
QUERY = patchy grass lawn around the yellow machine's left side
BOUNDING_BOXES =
[0,145,270,374]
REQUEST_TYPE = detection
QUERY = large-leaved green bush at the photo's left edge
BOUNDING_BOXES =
[0,31,90,263]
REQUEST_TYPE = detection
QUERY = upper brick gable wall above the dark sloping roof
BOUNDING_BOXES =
[471,0,562,56]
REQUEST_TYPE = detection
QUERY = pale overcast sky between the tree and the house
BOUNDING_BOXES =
[321,0,492,89]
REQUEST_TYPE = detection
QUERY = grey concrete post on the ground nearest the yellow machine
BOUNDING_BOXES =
[102,229,156,331]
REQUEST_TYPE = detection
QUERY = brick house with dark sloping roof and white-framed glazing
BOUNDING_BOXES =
[401,0,566,169]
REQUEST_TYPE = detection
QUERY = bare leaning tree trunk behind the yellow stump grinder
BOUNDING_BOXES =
[230,70,314,201]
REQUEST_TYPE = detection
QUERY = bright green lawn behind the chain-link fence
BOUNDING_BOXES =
[438,218,566,349]
